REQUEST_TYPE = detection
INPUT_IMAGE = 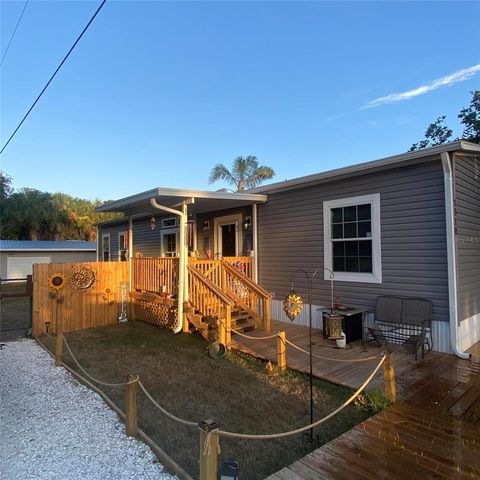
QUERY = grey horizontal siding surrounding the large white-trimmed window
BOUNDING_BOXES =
[258,159,449,322]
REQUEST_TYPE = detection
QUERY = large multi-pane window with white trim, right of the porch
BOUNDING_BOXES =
[323,193,382,283]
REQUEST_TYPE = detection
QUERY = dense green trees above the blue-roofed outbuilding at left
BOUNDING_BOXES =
[0,172,119,241]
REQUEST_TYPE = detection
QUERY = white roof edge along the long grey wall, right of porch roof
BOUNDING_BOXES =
[248,140,480,194]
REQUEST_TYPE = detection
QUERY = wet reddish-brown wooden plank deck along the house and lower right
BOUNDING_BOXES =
[233,322,480,480]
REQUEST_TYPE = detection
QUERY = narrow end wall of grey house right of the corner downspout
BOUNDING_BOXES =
[454,156,480,348]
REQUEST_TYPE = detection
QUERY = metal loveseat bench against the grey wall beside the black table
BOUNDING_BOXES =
[365,296,433,360]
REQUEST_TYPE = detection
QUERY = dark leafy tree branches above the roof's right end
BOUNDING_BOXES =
[410,90,480,151]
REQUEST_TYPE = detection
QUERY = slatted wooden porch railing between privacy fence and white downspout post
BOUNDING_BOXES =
[132,257,179,294]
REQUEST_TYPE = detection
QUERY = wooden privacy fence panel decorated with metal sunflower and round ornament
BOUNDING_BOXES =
[32,262,129,335]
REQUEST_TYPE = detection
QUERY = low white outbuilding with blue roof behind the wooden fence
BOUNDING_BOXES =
[0,240,96,279]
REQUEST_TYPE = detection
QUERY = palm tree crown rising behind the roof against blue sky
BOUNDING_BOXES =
[208,155,275,192]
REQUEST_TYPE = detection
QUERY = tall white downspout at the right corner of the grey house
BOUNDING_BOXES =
[440,152,471,359]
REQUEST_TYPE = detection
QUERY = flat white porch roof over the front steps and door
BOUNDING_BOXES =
[96,187,268,215]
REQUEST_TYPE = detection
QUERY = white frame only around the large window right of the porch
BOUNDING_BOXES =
[323,193,382,283]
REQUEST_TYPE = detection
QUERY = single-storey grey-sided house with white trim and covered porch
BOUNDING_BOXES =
[98,141,480,352]
